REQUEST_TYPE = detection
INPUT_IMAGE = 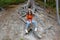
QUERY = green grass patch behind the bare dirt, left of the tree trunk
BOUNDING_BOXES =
[0,0,26,7]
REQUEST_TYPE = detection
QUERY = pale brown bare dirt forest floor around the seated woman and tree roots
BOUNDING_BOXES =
[0,5,60,40]
